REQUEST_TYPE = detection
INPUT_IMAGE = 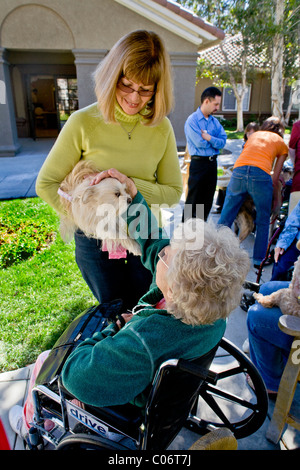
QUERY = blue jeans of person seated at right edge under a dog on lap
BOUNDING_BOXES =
[247,281,294,392]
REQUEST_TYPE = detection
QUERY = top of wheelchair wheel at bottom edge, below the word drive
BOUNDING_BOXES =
[56,433,128,450]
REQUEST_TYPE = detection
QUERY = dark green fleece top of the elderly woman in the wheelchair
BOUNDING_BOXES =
[62,193,226,407]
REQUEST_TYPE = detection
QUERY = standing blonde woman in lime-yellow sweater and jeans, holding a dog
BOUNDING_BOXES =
[36,31,182,308]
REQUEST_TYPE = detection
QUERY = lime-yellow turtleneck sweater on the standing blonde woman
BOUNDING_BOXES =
[36,103,182,217]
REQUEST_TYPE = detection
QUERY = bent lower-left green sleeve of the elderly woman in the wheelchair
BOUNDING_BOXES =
[62,328,154,407]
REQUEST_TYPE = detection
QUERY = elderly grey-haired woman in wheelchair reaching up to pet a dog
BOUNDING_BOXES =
[10,169,249,436]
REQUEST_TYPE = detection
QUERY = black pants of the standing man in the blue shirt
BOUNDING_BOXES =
[183,157,218,220]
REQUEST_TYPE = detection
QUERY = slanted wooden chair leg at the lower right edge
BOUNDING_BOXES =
[266,349,300,444]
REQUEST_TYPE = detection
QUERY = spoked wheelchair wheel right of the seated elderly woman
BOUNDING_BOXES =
[186,338,268,439]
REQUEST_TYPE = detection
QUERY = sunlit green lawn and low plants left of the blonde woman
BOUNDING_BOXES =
[0,198,95,372]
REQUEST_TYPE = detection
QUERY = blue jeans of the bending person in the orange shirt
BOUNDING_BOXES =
[218,166,273,264]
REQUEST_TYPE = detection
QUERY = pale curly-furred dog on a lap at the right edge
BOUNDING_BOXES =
[253,241,300,317]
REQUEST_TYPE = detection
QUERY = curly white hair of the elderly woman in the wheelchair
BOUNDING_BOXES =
[167,219,250,325]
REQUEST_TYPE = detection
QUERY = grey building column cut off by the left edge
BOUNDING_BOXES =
[0,47,20,157]
